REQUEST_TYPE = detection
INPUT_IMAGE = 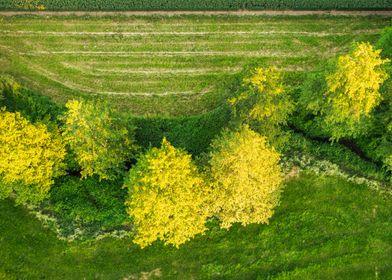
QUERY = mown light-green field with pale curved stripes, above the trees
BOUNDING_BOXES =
[0,16,390,116]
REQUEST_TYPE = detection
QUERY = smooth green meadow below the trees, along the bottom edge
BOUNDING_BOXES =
[0,174,392,280]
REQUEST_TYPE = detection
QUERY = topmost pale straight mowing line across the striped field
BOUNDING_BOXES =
[0,29,381,37]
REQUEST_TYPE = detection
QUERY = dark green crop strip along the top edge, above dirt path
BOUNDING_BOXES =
[0,0,392,11]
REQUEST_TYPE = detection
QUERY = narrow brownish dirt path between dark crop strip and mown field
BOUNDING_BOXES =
[0,10,392,17]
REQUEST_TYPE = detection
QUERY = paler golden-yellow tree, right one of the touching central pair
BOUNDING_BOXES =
[209,125,282,228]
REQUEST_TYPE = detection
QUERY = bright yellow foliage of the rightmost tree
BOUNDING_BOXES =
[326,43,389,121]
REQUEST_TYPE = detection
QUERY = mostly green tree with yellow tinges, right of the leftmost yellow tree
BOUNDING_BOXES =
[63,100,136,179]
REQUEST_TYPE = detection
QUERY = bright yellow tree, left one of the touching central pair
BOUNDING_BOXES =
[124,139,209,248]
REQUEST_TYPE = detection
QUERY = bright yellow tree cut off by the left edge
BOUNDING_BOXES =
[0,109,65,204]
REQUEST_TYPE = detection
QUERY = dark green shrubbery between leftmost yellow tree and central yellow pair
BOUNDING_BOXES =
[48,176,128,235]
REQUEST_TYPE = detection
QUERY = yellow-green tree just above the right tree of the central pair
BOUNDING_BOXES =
[229,68,294,146]
